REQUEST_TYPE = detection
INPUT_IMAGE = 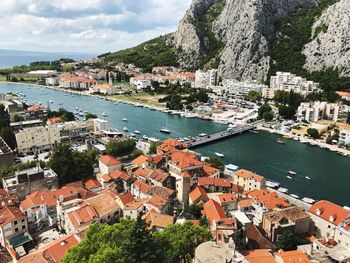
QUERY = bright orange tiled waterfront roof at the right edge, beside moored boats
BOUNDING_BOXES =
[309,200,350,225]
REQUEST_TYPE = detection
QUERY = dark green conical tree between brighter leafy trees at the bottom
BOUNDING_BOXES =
[122,215,163,263]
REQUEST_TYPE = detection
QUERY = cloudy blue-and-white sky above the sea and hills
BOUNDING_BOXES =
[0,0,191,54]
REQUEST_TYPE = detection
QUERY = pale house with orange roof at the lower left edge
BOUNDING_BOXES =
[0,206,31,250]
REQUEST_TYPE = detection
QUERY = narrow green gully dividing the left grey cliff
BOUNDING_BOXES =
[192,0,226,69]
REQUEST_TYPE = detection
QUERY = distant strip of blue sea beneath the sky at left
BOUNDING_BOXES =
[0,50,96,69]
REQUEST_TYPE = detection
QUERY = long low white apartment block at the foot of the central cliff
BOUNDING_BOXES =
[221,79,267,96]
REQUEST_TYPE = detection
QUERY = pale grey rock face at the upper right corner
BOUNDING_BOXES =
[303,0,350,76]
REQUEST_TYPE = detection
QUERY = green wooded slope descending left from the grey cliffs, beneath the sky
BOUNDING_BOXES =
[100,35,178,72]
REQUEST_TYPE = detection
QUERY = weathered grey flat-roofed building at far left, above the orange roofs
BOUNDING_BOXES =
[2,166,58,200]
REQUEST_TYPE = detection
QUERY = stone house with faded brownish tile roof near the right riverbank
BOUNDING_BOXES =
[262,206,310,242]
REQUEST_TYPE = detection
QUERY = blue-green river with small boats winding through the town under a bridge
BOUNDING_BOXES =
[0,84,350,206]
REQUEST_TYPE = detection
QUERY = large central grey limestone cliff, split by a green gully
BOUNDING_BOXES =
[172,0,322,80]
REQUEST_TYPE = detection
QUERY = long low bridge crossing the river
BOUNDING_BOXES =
[187,124,256,148]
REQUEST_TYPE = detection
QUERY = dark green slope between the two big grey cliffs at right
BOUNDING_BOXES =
[268,0,350,101]
